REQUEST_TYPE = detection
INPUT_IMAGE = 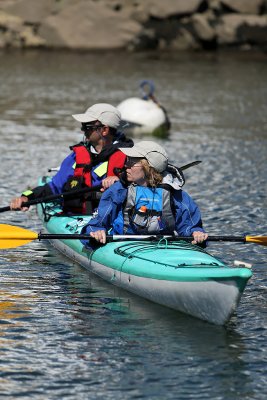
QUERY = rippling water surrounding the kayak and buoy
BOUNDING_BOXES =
[0,52,267,400]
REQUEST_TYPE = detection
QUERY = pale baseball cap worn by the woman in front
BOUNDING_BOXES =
[119,140,168,172]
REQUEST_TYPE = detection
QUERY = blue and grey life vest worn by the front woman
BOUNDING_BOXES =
[113,184,175,234]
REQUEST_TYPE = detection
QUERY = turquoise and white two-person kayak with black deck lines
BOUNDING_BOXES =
[38,178,252,325]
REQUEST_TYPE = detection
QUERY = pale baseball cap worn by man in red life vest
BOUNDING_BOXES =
[73,103,121,128]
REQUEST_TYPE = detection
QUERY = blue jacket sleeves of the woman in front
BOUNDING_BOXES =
[82,182,204,244]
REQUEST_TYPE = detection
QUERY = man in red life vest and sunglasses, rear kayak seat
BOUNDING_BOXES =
[10,103,133,214]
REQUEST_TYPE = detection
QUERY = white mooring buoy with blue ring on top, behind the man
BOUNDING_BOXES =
[117,80,170,137]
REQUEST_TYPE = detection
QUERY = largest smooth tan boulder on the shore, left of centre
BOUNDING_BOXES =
[39,1,142,49]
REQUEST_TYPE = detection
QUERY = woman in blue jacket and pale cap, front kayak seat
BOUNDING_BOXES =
[82,141,208,247]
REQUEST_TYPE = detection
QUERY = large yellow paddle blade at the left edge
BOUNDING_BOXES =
[0,224,38,249]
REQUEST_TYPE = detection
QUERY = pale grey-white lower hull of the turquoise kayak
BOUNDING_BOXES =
[51,240,247,325]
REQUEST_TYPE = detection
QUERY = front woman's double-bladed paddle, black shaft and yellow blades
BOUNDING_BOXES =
[0,224,267,249]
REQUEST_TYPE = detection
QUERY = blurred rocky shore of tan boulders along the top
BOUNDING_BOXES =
[0,0,267,52]
